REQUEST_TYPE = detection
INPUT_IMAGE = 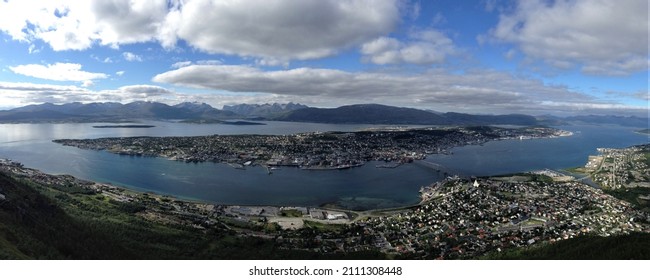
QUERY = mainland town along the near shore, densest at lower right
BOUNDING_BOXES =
[0,144,650,259]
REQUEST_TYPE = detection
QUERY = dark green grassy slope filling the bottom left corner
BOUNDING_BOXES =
[0,172,384,259]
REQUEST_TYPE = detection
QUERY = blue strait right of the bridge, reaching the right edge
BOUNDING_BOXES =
[426,125,650,176]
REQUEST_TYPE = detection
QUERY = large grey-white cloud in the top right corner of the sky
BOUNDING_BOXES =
[490,0,649,75]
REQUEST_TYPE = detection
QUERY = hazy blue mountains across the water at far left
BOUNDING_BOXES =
[0,101,238,122]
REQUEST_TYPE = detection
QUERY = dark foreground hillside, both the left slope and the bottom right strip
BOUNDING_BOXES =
[0,166,650,260]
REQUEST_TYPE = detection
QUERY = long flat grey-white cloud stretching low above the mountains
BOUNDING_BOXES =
[153,65,640,114]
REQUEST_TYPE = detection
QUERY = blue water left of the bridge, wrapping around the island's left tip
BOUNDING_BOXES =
[0,122,441,209]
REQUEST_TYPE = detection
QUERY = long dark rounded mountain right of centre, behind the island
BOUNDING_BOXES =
[276,104,537,125]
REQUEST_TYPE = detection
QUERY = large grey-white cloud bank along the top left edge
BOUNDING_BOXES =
[0,0,403,61]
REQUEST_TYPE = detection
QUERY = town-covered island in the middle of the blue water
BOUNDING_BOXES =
[54,126,571,172]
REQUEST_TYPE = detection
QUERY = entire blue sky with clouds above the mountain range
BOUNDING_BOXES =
[0,0,650,116]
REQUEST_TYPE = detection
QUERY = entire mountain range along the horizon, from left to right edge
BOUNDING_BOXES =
[0,101,648,127]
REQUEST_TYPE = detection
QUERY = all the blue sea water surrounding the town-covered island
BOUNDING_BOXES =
[0,121,650,210]
